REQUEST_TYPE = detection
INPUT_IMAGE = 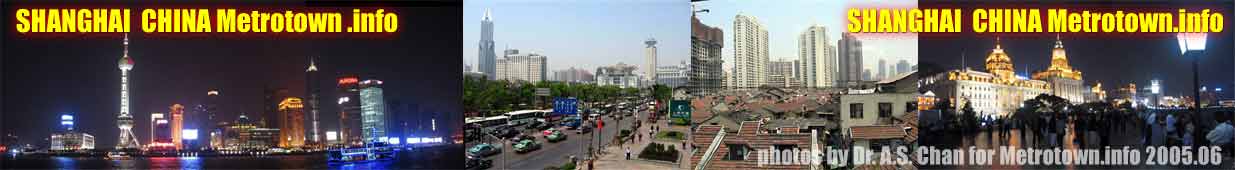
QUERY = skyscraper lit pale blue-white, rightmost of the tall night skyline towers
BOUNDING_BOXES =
[361,80,387,142]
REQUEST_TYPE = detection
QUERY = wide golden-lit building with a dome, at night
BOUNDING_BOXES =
[919,39,1051,116]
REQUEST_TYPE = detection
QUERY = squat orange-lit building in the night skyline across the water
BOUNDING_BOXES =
[279,97,305,148]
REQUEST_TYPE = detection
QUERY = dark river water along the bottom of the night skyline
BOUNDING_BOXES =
[0,147,464,170]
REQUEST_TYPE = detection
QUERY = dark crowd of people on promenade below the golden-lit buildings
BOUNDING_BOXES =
[987,107,1235,154]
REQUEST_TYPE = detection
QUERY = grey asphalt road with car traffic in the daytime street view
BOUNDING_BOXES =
[468,112,634,170]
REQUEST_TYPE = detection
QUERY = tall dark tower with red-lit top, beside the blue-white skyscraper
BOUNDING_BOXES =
[336,74,363,145]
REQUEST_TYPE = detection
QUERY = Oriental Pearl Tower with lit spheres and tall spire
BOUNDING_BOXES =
[116,34,140,150]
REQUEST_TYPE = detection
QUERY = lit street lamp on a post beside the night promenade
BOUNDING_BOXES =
[1176,32,1207,141]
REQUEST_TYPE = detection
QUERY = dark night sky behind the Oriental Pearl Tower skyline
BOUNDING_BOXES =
[0,0,462,148]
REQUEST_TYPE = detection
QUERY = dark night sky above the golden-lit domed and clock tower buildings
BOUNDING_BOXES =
[918,1,1235,96]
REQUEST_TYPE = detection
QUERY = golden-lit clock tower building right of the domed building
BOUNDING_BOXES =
[1034,34,1086,103]
